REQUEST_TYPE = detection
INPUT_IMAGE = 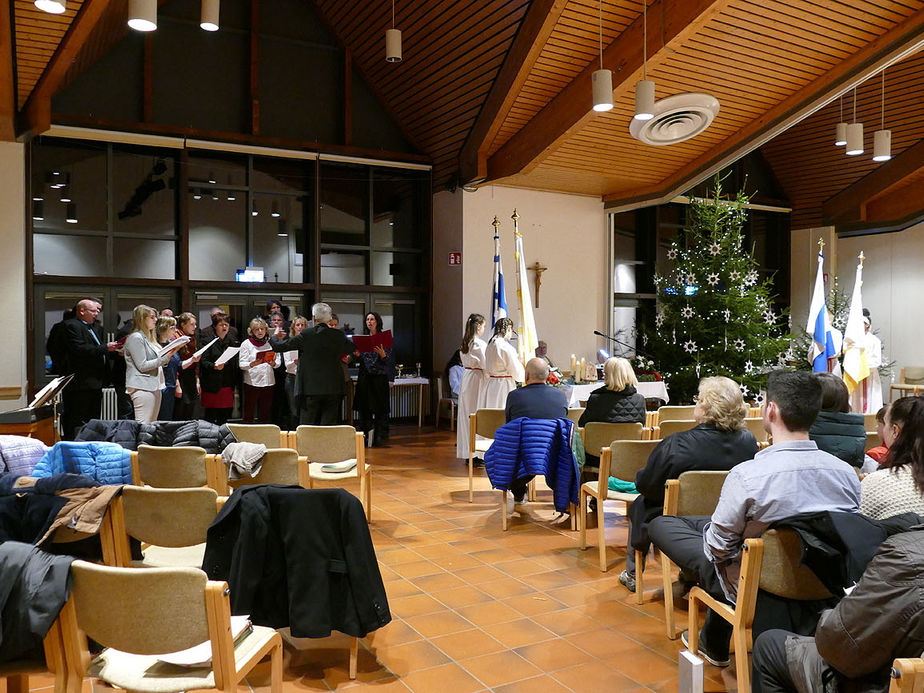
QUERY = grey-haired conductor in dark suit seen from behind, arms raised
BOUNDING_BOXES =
[270,303,353,426]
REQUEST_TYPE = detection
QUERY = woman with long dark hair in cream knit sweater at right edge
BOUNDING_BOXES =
[860,396,924,520]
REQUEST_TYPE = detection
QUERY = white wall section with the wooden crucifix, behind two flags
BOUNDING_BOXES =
[460,186,608,369]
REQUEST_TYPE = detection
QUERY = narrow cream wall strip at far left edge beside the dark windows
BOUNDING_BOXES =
[0,142,26,411]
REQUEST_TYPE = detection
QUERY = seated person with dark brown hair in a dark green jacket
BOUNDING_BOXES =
[809,373,866,467]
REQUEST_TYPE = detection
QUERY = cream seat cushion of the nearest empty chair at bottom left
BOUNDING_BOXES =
[88,626,276,693]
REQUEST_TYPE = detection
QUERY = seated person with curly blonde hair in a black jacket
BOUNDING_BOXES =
[620,376,757,592]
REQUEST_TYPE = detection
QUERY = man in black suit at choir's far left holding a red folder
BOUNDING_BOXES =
[61,298,119,440]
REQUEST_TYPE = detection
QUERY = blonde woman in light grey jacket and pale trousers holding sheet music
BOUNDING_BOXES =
[125,305,182,423]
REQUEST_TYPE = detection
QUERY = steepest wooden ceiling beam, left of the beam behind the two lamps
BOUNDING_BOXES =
[459,0,568,183]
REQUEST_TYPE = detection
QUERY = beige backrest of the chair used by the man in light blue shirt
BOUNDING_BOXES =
[760,529,833,600]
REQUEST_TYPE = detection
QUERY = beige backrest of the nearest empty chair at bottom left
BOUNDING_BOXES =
[71,561,210,655]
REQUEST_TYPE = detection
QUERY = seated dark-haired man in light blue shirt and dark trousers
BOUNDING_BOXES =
[648,371,860,666]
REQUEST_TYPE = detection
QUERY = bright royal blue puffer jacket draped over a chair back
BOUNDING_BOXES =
[484,417,578,512]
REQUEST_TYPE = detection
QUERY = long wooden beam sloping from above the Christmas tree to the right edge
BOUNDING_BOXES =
[603,12,924,211]
